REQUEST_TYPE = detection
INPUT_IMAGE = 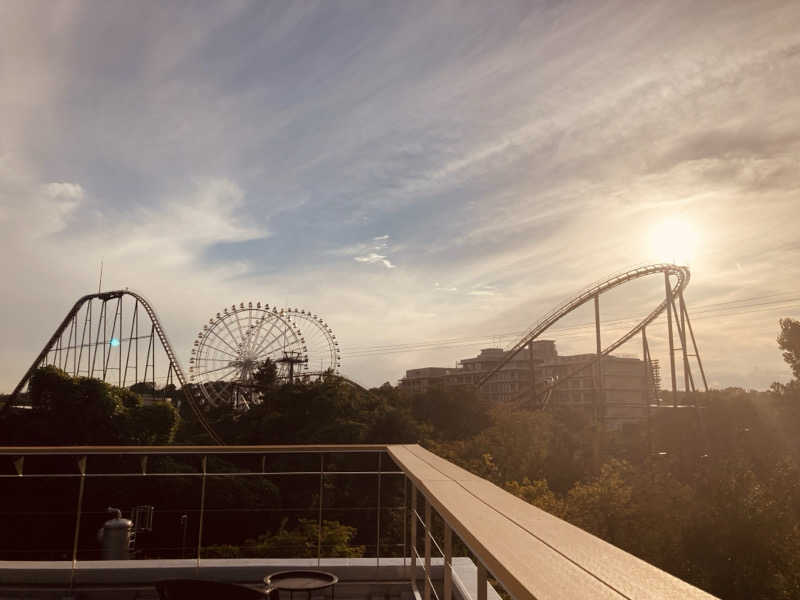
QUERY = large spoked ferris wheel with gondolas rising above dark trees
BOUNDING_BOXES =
[189,302,341,408]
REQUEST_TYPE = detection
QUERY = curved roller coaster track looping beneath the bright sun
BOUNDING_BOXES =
[476,264,692,395]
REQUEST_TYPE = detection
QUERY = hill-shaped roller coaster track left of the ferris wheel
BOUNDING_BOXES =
[3,289,223,444]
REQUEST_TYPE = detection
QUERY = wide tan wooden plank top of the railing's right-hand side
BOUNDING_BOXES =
[389,445,713,600]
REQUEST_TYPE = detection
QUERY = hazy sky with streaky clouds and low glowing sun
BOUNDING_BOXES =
[0,0,800,391]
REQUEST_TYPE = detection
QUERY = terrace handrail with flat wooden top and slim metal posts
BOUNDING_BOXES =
[0,444,711,600]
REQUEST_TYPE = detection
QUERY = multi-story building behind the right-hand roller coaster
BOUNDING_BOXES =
[400,340,658,429]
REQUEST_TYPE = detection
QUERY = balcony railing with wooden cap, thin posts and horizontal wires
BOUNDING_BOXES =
[0,445,711,600]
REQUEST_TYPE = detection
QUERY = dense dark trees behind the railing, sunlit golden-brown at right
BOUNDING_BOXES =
[0,319,800,599]
